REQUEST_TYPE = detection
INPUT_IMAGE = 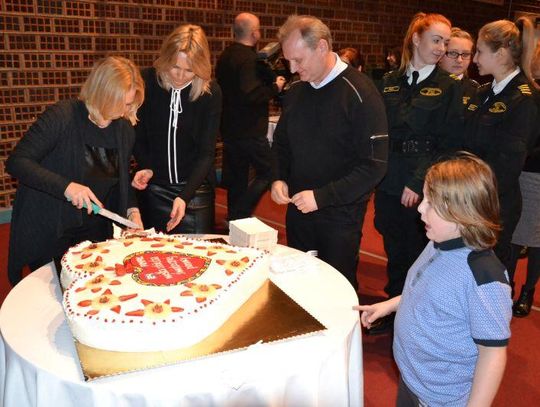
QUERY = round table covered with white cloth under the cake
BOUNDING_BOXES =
[0,236,363,407]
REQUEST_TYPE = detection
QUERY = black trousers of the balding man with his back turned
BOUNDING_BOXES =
[223,136,271,220]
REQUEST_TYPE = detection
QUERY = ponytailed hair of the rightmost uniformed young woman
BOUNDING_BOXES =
[478,17,536,83]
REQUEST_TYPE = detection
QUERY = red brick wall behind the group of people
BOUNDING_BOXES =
[0,0,540,208]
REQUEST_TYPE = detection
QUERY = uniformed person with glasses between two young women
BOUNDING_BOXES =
[439,27,480,106]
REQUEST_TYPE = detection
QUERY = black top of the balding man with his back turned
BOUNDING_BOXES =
[216,42,278,141]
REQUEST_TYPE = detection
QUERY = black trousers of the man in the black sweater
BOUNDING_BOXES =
[286,202,367,292]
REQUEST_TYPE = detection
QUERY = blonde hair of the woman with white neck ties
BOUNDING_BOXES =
[154,24,212,101]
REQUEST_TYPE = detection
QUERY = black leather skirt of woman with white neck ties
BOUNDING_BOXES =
[138,183,215,234]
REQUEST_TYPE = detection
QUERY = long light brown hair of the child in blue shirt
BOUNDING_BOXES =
[424,152,501,250]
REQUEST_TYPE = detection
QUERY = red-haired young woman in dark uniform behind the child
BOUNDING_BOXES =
[368,13,464,334]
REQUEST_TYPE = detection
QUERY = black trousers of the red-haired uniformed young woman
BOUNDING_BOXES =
[375,190,427,297]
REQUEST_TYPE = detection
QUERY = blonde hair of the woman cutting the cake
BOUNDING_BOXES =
[79,56,144,125]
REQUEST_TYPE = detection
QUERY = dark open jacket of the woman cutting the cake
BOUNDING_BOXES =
[6,100,135,282]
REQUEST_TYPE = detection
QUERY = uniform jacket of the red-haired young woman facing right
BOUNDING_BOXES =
[378,67,464,196]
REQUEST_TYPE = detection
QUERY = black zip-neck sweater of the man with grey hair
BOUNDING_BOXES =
[272,66,388,224]
